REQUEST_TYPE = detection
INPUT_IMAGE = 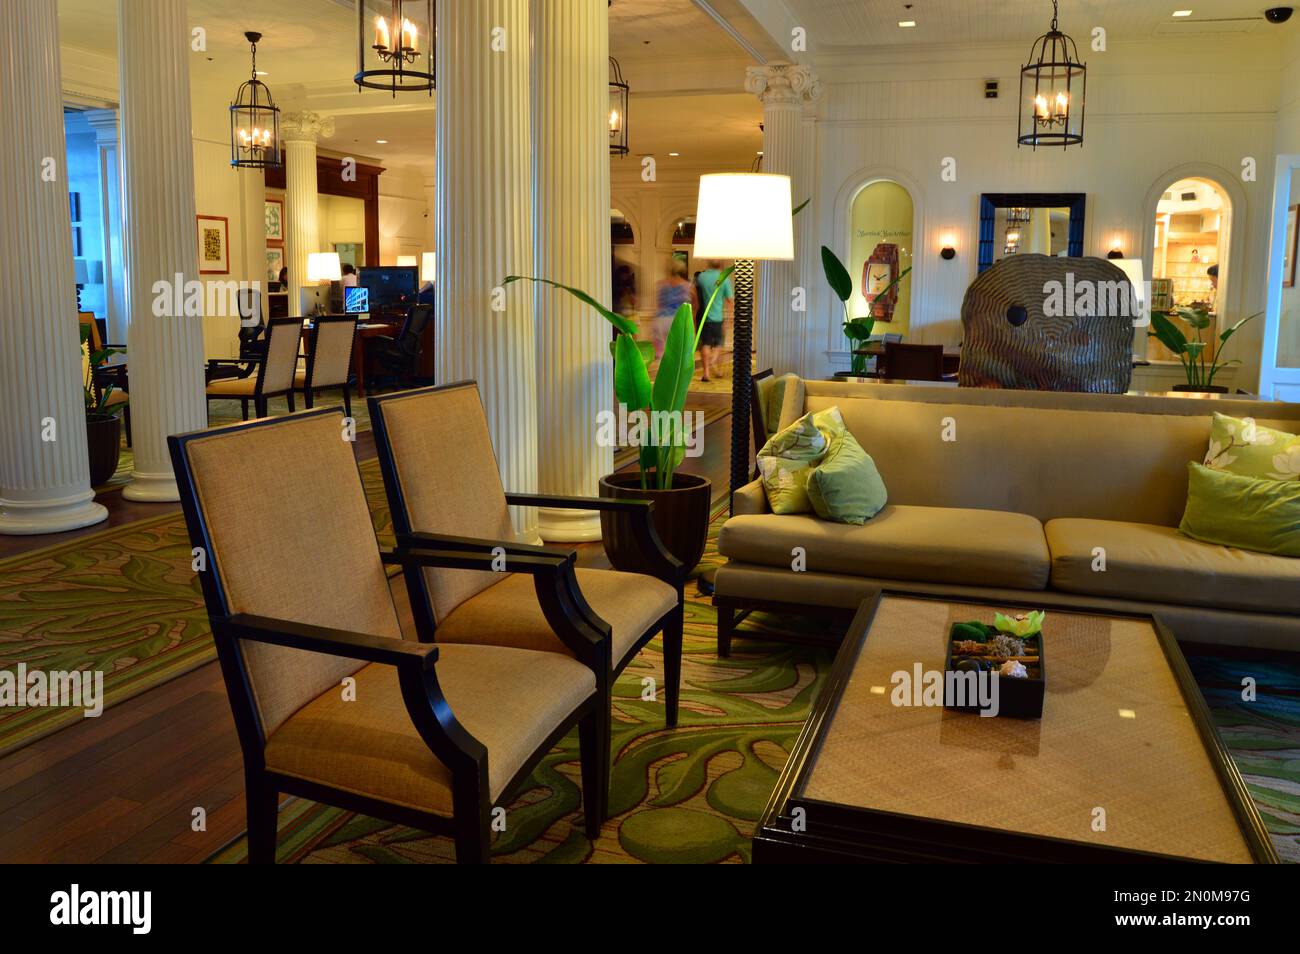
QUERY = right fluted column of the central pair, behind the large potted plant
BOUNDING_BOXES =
[533,0,614,541]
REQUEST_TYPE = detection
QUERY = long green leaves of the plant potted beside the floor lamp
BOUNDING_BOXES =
[504,265,736,490]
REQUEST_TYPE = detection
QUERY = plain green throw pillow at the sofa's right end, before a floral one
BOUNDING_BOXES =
[1178,463,1300,556]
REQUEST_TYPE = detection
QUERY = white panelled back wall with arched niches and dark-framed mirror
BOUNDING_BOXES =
[805,35,1296,386]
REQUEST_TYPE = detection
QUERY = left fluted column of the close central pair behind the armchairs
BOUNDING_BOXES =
[434,0,538,539]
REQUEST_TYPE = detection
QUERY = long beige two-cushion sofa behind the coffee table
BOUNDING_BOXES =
[714,378,1300,655]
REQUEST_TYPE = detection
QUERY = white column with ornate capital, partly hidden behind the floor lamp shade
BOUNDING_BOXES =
[736,62,816,374]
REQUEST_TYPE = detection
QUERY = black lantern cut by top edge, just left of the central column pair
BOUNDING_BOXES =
[352,0,437,97]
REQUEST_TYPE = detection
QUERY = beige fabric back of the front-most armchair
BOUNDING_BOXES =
[185,411,402,736]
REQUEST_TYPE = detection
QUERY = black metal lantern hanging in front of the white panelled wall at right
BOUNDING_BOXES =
[1017,0,1088,149]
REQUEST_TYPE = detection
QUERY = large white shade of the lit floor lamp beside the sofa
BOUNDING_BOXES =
[694,173,794,261]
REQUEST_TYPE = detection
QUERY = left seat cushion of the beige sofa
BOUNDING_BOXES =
[718,504,1049,590]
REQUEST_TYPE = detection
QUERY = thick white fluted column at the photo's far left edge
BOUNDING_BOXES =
[0,0,108,533]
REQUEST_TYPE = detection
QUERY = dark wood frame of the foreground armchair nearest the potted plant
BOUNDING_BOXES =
[367,381,686,816]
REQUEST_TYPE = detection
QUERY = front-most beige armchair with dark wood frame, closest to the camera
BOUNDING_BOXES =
[168,408,608,863]
